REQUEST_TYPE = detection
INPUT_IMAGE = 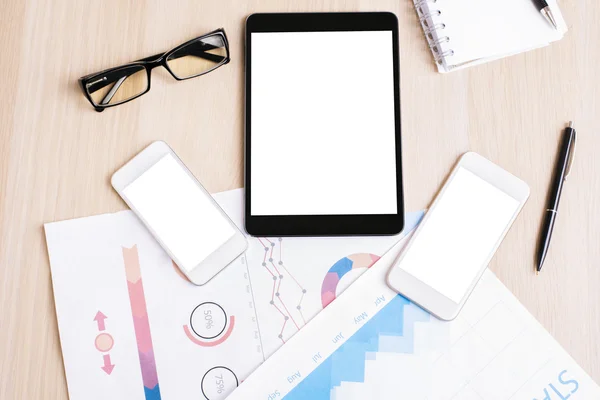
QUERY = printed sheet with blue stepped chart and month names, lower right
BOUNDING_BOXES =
[227,233,600,400]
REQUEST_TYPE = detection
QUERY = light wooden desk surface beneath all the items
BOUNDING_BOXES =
[0,0,600,400]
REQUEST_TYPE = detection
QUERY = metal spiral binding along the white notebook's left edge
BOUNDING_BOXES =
[414,0,454,64]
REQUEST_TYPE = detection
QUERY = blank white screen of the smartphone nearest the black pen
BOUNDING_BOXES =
[399,167,520,304]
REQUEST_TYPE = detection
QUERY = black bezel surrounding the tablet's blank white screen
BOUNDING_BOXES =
[244,12,404,236]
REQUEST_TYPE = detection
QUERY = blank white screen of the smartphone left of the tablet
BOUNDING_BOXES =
[122,154,236,272]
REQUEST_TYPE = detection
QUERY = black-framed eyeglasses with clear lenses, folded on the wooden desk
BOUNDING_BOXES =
[79,29,230,112]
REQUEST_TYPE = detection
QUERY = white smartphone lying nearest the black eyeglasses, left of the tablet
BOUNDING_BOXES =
[111,141,248,285]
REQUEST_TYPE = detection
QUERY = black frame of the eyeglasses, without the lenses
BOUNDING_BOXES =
[79,28,231,112]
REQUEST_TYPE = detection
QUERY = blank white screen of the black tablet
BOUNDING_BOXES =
[250,30,399,216]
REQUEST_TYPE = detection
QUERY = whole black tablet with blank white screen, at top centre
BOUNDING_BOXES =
[245,13,404,236]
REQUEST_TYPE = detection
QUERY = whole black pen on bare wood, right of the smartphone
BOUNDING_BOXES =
[537,122,577,273]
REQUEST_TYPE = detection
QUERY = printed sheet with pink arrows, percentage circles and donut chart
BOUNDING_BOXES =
[45,190,422,400]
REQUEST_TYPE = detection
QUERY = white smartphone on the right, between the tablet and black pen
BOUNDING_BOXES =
[387,153,529,320]
